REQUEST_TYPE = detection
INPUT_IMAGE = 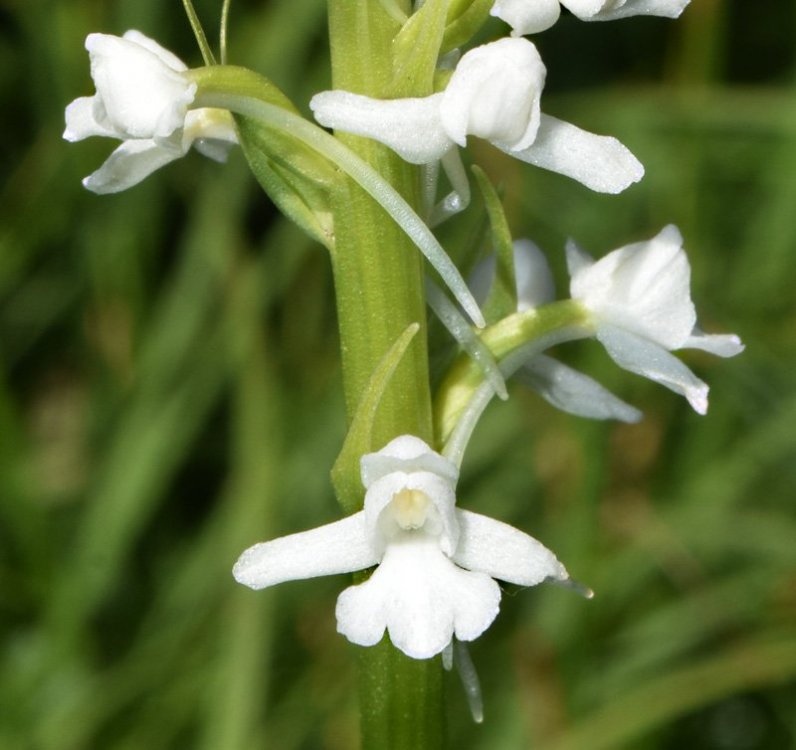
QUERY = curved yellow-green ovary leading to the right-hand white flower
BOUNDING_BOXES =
[434,300,593,445]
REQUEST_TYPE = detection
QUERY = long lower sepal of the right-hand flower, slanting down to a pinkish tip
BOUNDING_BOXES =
[597,324,708,414]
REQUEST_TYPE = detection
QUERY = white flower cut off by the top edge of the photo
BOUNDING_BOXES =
[490,0,691,36]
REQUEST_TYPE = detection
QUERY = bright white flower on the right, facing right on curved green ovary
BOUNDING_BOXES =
[567,225,744,414]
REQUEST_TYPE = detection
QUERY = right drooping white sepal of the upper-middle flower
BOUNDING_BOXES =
[504,114,644,193]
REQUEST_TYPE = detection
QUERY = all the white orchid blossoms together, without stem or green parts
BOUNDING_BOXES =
[64,0,743,659]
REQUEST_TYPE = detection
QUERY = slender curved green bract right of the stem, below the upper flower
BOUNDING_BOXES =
[472,166,517,322]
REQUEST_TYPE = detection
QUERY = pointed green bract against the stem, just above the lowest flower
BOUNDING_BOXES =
[332,323,420,513]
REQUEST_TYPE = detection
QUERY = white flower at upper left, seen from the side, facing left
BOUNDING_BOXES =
[64,31,237,193]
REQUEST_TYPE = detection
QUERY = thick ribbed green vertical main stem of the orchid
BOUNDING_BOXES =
[329,0,443,748]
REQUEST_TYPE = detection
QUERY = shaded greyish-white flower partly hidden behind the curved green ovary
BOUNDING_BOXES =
[470,239,642,422]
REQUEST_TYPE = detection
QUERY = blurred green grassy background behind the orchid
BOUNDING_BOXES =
[0,0,796,750]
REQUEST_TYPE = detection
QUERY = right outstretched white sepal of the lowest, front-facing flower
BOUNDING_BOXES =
[453,510,569,586]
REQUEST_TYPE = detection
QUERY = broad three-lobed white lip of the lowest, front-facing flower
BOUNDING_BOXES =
[336,534,500,659]
